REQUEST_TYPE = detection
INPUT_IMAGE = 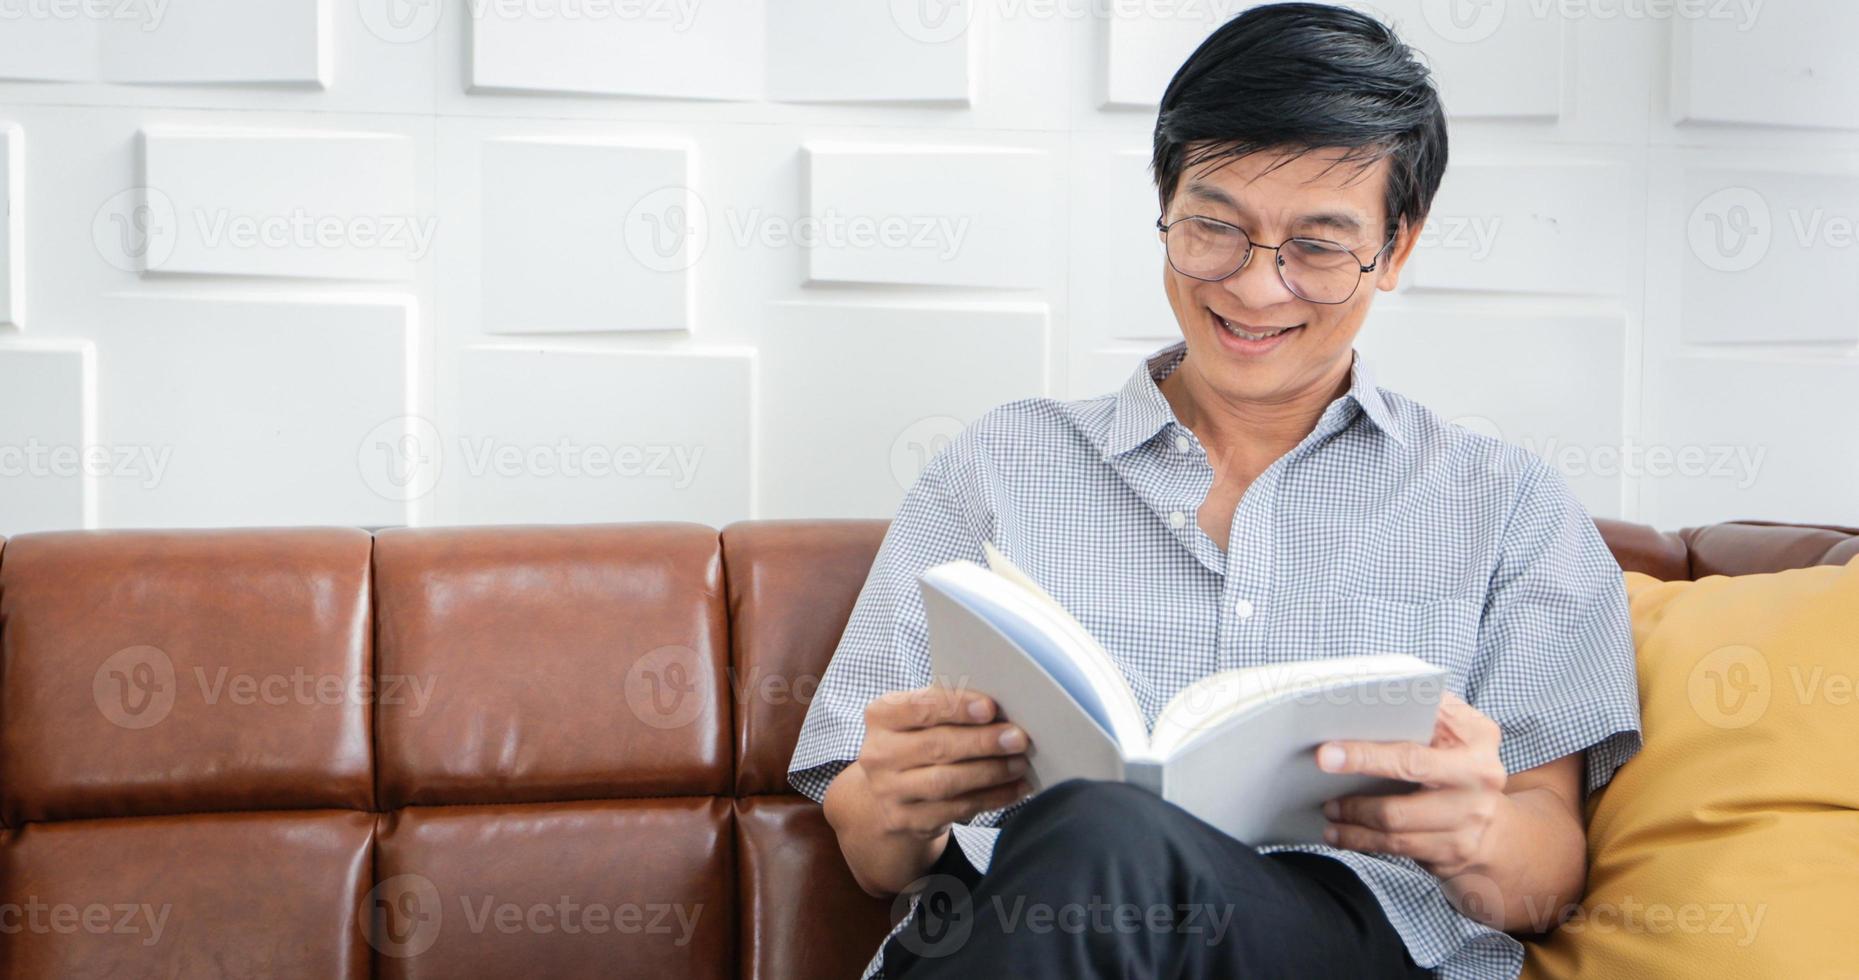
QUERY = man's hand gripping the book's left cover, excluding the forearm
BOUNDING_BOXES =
[859,686,1028,839]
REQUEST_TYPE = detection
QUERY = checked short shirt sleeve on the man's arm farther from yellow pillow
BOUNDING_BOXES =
[788,437,987,801]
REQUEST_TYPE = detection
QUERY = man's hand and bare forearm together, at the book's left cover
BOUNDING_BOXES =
[825,686,1030,894]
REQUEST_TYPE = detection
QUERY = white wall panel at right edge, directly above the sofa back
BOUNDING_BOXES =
[1640,357,1859,528]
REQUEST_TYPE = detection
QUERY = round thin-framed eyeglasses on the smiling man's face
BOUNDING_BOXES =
[1156,214,1394,305]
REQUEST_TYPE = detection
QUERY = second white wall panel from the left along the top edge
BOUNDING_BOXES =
[100,0,327,86]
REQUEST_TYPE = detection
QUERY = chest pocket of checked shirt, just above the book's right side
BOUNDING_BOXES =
[1316,595,1483,690]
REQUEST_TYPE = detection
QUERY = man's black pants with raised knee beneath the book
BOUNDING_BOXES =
[885,781,1430,980]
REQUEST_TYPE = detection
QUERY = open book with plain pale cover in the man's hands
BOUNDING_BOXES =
[920,545,1444,844]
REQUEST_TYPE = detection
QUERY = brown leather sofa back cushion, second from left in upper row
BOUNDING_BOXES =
[376,524,731,809]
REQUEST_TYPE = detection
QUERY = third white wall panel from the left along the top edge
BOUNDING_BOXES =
[470,0,764,99]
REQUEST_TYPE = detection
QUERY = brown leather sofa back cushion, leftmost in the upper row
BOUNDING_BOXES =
[0,528,374,826]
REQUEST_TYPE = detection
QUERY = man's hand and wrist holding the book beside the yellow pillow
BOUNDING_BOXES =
[1316,692,1588,932]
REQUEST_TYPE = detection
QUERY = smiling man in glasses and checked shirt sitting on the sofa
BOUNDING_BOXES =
[790,4,1640,978]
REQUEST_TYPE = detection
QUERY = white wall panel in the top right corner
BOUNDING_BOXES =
[1671,0,1859,128]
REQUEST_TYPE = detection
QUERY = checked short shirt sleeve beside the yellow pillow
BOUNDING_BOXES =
[1467,463,1640,792]
